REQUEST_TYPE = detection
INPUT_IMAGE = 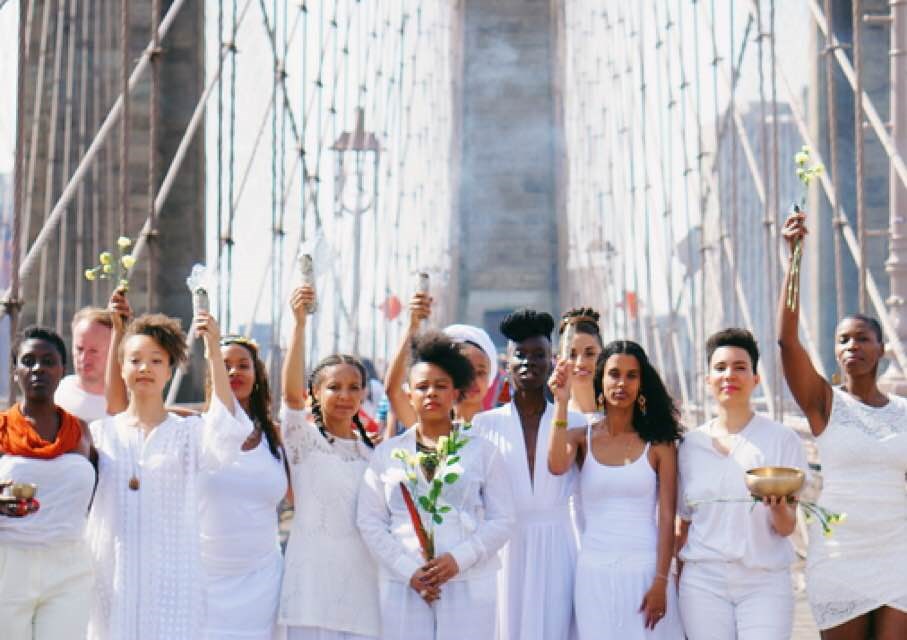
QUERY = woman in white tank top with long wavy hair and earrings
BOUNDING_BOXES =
[548,340,683,640]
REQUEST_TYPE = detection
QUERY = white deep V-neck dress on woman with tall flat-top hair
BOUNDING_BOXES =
[473,403,586,640]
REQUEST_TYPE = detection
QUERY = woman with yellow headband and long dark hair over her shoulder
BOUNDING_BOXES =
[105,291,288,640]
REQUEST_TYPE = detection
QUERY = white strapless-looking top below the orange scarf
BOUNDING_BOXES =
[0,453,94,547]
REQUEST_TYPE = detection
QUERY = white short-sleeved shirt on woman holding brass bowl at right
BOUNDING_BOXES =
[677,414,808,570]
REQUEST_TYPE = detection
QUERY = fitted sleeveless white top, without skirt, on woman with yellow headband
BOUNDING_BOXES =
[200,436,287,575]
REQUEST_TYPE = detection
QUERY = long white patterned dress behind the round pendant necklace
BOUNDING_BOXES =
[86,397,252,640]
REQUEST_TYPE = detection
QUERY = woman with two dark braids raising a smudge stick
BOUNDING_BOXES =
[279,286,380,640]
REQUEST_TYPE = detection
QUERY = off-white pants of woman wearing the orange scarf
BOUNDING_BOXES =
[0,542,92,640]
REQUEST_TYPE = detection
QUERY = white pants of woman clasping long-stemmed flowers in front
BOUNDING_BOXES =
[379,573,500,640]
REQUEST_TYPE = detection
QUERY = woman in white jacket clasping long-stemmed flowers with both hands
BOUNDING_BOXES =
[358,333,516,640]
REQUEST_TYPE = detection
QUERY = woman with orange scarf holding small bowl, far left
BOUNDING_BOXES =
[0,327,95,640]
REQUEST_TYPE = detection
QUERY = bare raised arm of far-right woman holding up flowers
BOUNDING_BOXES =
[778,212,831,436]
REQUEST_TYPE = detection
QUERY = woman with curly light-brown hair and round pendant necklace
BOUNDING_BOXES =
[87,313,252,640]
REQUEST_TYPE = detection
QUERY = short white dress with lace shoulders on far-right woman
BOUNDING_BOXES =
[806,389,907,629]
